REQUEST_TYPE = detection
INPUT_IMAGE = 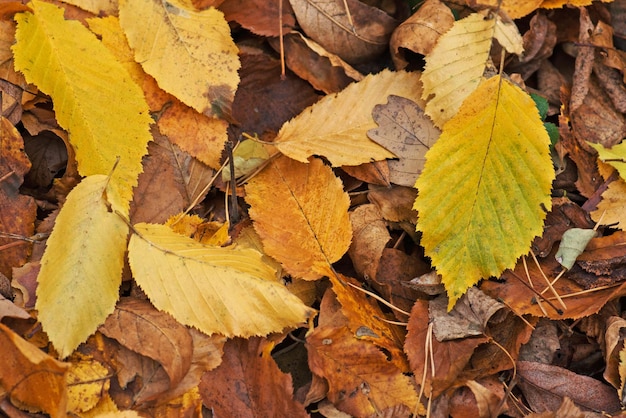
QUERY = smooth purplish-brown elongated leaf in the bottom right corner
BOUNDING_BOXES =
[517,361,621,412]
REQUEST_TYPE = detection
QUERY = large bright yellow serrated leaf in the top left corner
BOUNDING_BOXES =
[13,0,152,212]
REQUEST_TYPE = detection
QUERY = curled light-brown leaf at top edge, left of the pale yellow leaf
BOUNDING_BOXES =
[389,0,454,70]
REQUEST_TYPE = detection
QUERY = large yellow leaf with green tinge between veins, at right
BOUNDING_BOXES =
[415,76,554,308]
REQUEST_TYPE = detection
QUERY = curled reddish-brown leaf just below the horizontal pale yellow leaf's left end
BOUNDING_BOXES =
[100,298,193,387]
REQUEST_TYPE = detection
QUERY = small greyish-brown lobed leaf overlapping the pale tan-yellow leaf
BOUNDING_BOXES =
[367,95,441,187]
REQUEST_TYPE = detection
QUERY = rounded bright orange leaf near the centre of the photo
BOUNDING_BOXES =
[246,156,352,280]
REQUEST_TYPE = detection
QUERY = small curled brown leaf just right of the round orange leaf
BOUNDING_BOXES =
[348,204,391,279]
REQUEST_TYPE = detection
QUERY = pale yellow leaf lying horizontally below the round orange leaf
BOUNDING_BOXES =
[128,224,313,337]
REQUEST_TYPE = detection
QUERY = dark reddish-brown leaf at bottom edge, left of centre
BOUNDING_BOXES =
[200,337,308,417]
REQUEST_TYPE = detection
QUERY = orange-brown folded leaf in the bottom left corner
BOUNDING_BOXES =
[0,324,69,418]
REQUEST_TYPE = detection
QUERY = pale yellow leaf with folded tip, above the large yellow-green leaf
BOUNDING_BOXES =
[422,13,522,127]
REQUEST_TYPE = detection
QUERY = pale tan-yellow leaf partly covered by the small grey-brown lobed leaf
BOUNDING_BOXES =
[274,71,422,167]
